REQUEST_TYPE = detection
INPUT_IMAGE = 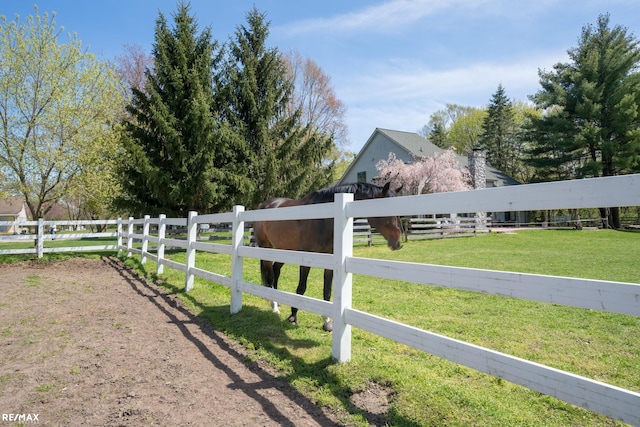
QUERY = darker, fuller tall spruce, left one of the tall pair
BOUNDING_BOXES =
[118,3,248,215]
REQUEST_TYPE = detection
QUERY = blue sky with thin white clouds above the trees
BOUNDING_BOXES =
[0,0,640,152]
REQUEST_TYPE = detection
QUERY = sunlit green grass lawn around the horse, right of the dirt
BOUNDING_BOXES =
[119,230,640,426]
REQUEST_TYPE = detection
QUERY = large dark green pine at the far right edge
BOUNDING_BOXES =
[532,14,640,228]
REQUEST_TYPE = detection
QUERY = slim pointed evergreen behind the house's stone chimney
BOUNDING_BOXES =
[480,84,518,176]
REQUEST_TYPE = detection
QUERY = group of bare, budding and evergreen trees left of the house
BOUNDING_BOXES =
[0,2,347,221]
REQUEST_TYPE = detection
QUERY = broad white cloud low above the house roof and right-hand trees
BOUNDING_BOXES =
[336,52,568,152]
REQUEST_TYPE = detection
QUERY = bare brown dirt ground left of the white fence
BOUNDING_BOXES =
[0,257,348,426]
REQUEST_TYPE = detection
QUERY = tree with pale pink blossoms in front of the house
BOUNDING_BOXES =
[376,149,472,195]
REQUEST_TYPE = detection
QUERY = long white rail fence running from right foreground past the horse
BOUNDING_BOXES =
[121,175,640,425]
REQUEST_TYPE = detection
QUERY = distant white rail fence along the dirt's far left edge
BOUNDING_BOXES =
[0,219,121,258]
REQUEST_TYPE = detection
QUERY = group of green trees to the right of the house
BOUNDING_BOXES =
[422,14,640,228]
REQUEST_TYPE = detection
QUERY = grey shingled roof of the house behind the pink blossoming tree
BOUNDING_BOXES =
[347,128,520,186]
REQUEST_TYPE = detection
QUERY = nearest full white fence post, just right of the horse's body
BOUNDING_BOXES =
[331,193,353,362]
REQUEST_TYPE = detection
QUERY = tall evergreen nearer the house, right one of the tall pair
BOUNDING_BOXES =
[218,7,333,207]
